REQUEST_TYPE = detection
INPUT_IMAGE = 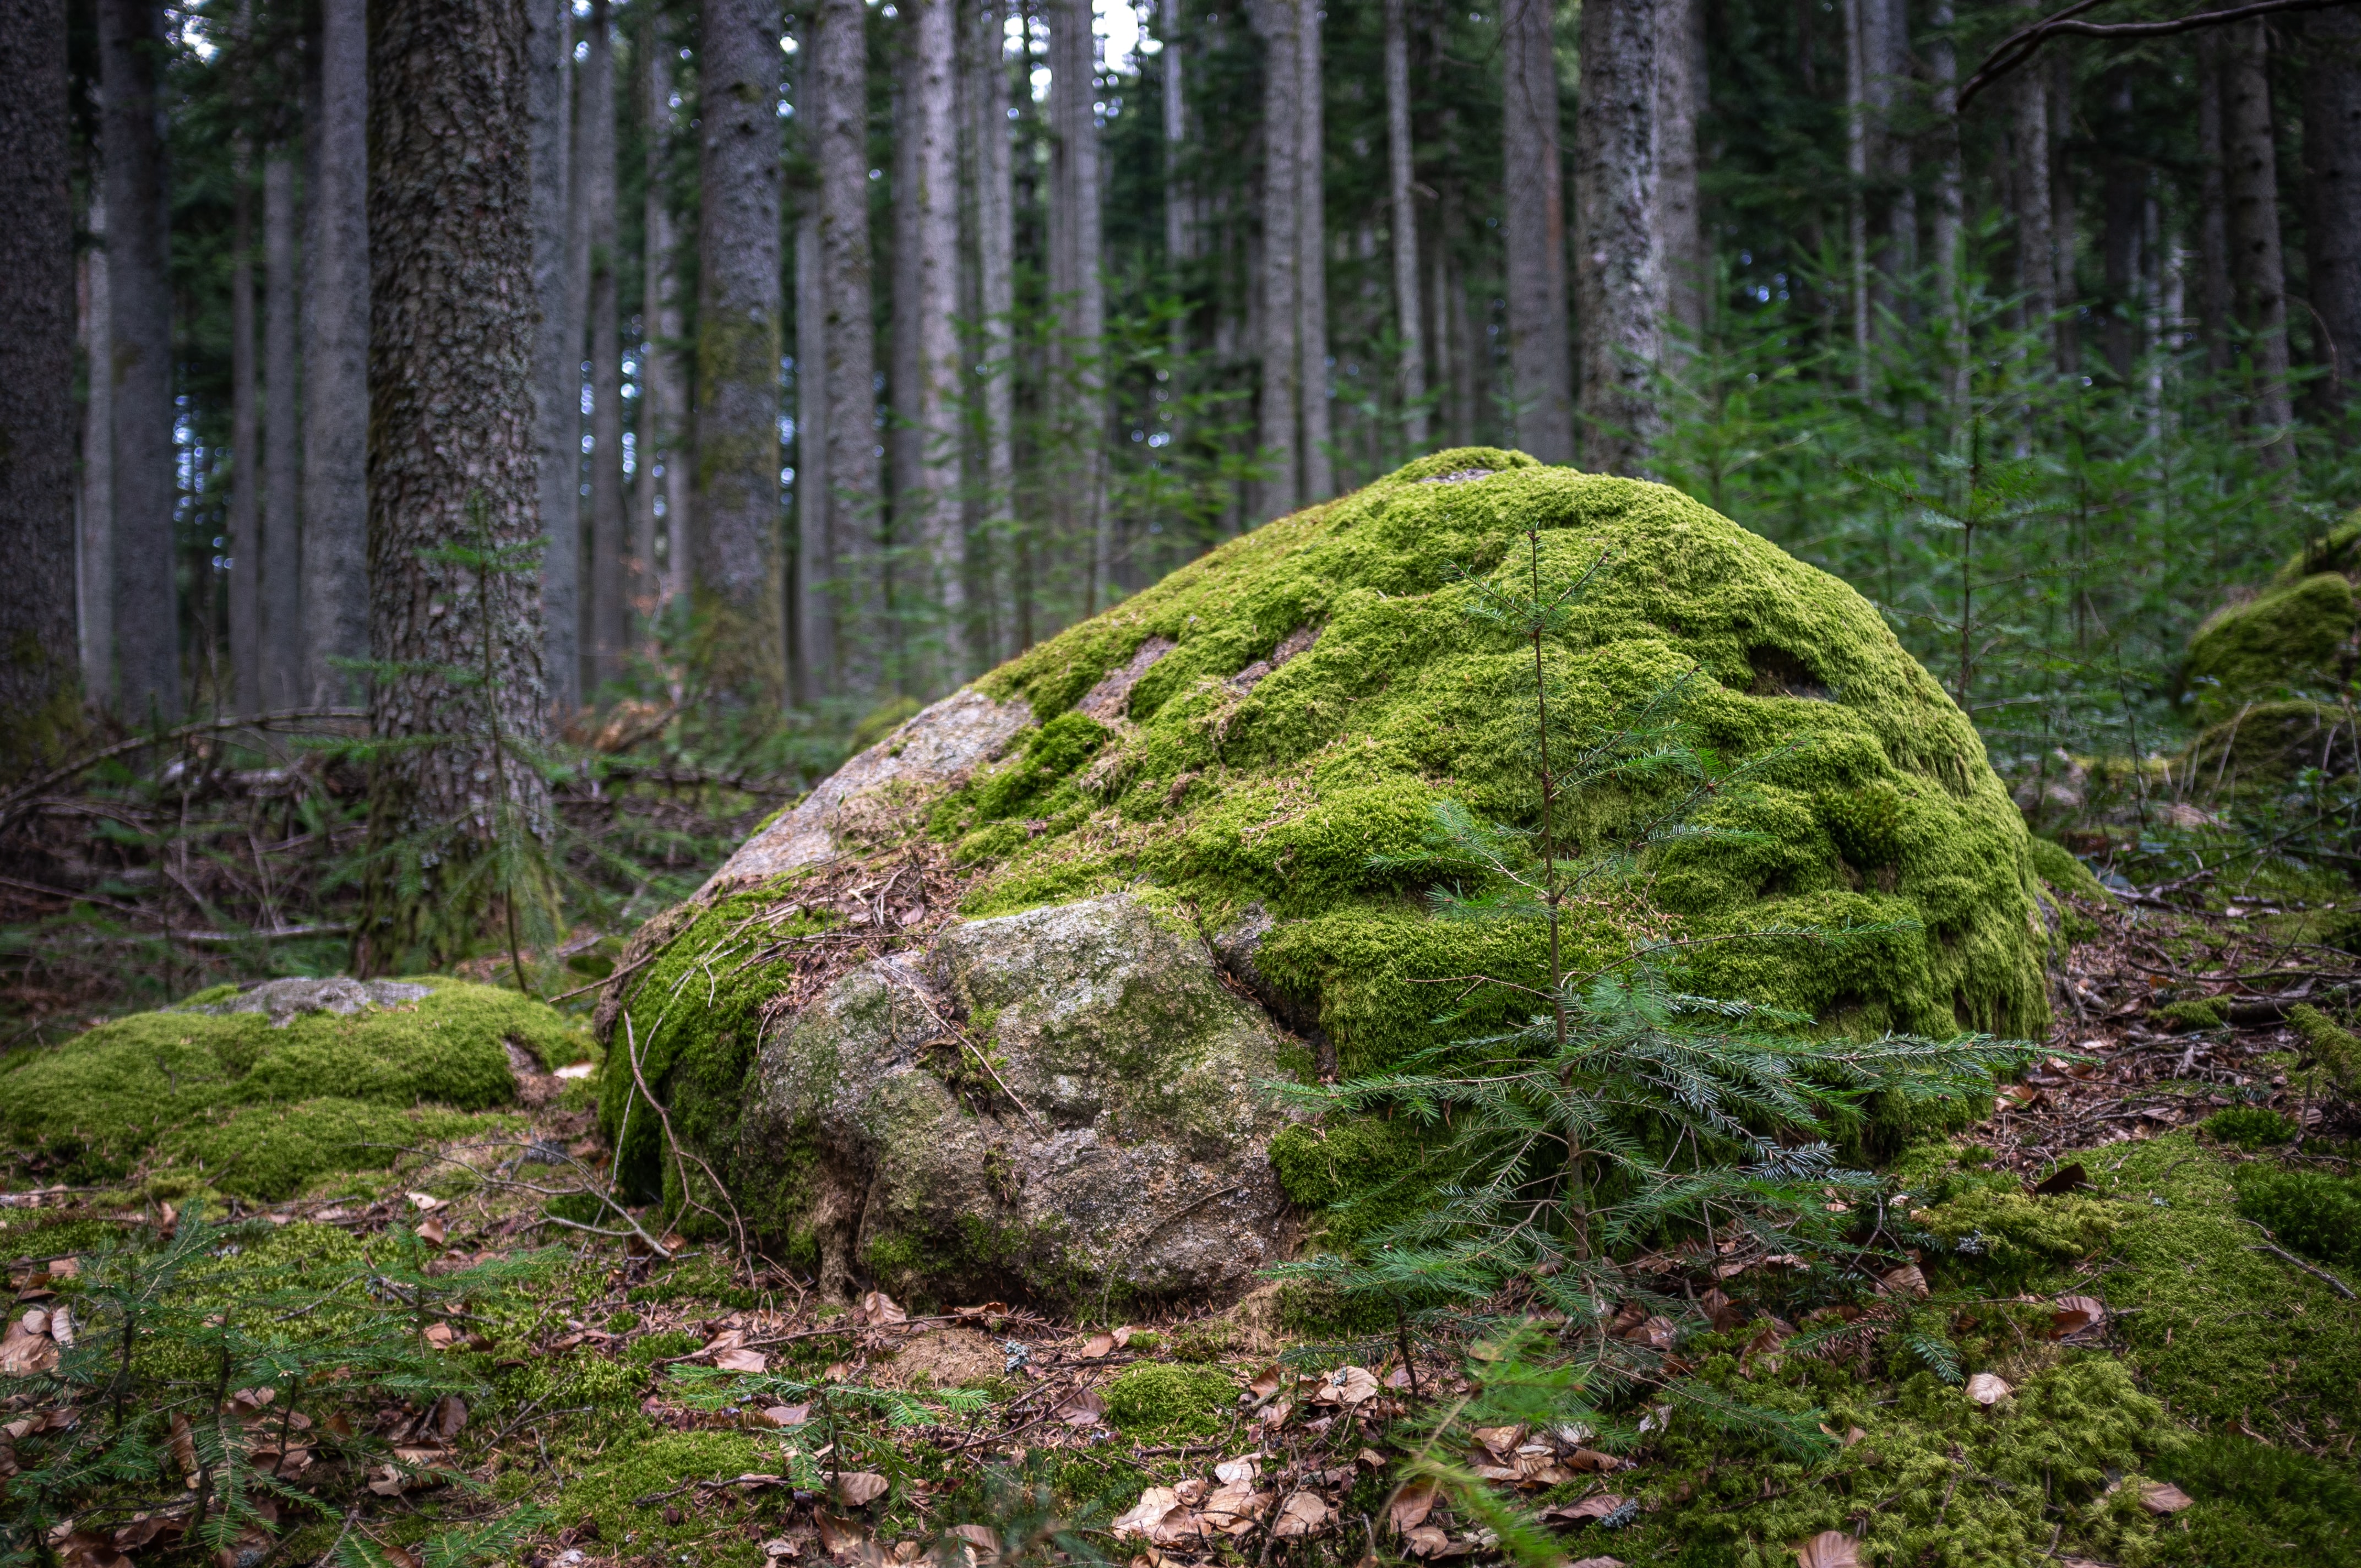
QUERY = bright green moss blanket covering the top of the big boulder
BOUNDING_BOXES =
[935,449,2047,1072]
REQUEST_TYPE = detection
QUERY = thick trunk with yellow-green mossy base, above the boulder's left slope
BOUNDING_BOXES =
[697,0,786,711]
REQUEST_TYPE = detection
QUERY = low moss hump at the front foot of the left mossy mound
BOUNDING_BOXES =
[158,1096,510,1202]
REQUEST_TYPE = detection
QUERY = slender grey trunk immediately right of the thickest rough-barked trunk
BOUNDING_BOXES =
[524,0,583,722]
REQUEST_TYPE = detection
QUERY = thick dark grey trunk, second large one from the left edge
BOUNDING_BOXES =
[99,0,179,722]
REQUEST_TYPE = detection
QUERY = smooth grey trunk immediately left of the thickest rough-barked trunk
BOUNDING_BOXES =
[302,0,368,704]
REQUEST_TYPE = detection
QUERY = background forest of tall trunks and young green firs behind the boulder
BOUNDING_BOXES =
[0,0,2361,1006]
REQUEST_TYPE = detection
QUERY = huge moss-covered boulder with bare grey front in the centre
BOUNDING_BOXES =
[600,449,2047,1301]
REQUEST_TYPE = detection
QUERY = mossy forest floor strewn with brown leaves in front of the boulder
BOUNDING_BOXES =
[14,873,2361,1568]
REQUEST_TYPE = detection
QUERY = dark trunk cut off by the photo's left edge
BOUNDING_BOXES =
[0,0,80,760]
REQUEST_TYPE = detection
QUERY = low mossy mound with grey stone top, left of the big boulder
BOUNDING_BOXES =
[0,978,588,1200]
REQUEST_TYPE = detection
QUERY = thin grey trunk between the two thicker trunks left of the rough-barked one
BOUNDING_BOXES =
[262,149,304,709]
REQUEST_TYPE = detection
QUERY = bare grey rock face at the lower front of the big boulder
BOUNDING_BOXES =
[737,895,1310,1304]
